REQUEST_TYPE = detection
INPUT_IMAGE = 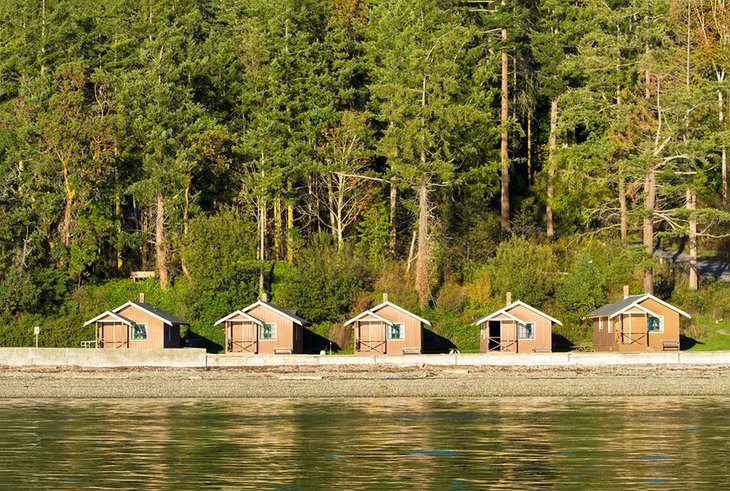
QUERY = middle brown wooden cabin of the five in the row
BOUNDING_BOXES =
[345,293,431,355]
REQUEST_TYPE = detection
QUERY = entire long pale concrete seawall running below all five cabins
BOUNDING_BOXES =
[0,348,730,368]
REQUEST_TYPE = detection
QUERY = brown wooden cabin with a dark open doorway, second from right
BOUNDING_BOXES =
[474,293,563,353]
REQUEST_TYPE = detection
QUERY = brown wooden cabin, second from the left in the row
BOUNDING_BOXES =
[214,294,309,354]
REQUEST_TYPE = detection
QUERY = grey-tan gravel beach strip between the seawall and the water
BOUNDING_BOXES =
[0,365,730,399]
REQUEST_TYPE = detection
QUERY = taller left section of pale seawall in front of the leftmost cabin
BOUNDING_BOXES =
[0,348,206,368]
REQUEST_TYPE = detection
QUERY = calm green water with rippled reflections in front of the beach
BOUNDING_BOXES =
[0,398,730,489]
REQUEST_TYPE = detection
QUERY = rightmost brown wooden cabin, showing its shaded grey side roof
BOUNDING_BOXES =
[585,287,690,352]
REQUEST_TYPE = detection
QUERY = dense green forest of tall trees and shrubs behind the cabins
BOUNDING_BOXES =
[0,0,730,350]
